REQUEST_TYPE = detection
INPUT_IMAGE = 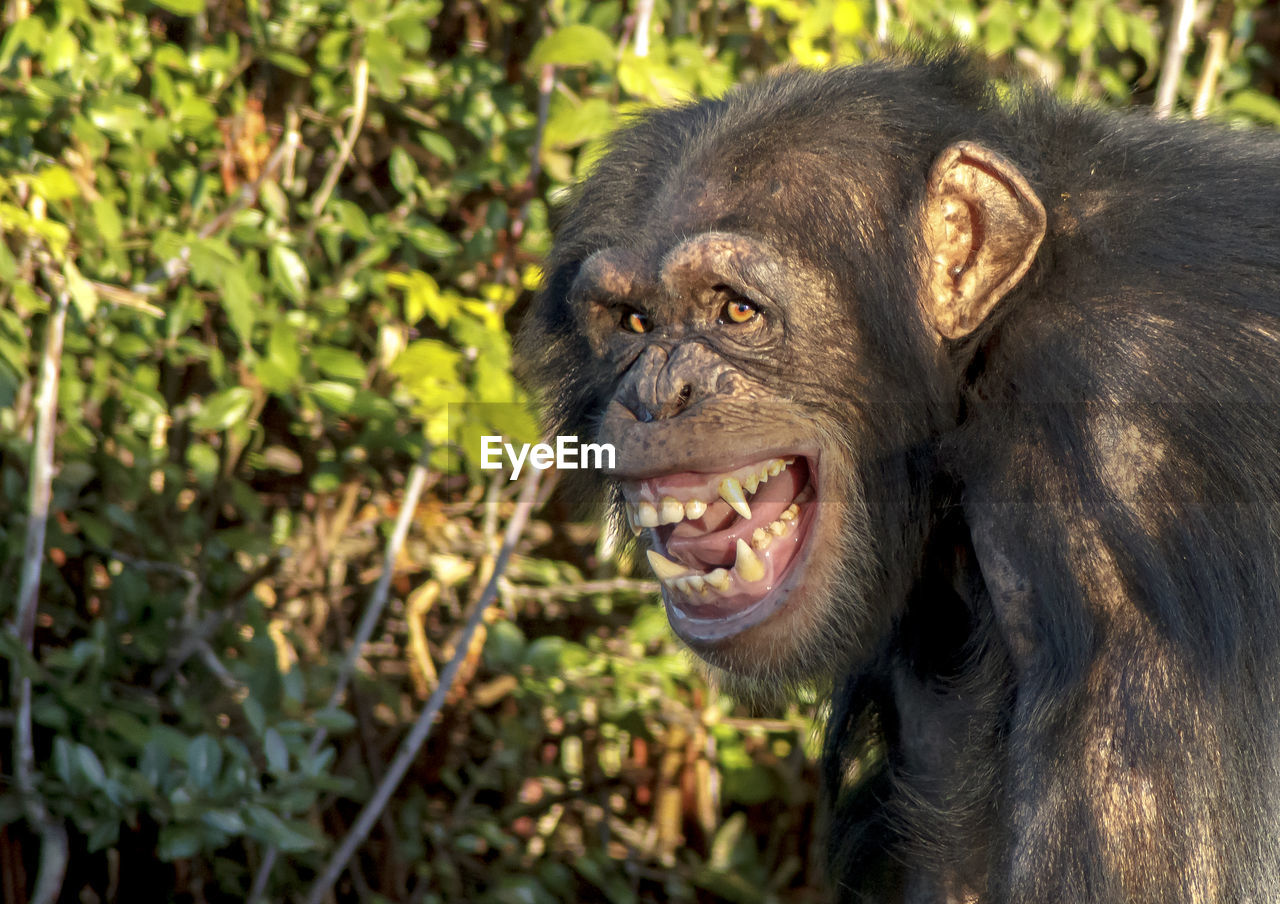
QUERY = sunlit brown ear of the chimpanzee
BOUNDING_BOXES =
[923,141,1044,339]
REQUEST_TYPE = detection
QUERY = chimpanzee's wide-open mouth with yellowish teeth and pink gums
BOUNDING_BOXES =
[622,455,817,627]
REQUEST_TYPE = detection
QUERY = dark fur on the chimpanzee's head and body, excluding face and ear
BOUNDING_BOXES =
[524,56,1280,904]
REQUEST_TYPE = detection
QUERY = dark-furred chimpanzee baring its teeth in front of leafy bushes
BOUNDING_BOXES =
[521,51,1280,904]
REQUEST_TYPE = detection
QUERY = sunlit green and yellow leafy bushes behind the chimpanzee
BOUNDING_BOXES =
[0,0,1280,904]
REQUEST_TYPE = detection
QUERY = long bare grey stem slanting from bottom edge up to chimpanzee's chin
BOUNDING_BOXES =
[306,470,543,904]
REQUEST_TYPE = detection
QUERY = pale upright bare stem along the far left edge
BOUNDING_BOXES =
[9,281,70,904]
